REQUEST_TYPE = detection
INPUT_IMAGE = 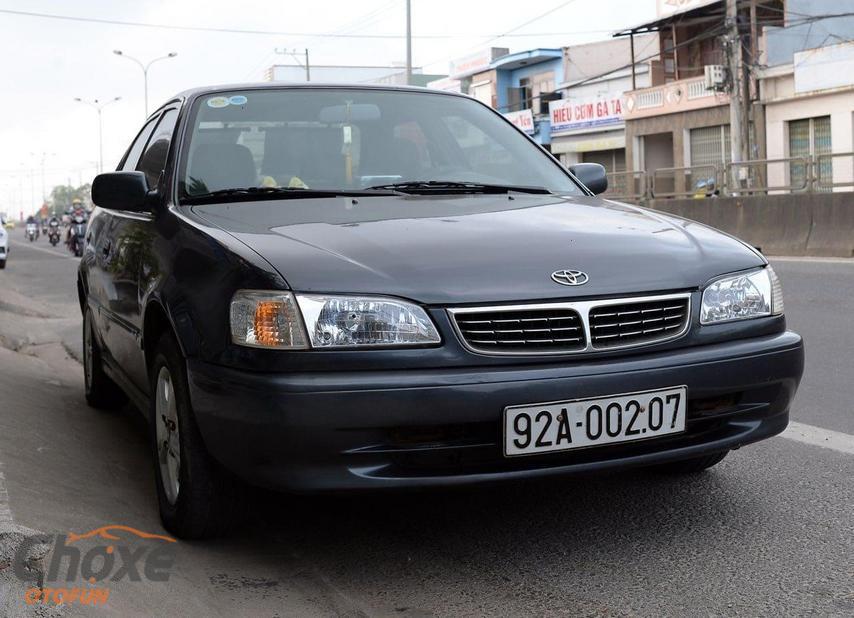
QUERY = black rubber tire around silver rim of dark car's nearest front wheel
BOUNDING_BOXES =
[149,334,243,539]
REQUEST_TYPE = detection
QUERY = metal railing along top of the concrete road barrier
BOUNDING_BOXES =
[604,152,854,202]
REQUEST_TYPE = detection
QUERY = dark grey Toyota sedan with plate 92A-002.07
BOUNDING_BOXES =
[78,84,803,538]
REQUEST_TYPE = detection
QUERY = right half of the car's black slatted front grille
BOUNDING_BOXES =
[589,298,688,348]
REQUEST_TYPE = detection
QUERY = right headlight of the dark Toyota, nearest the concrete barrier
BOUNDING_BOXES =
[700,266,783,324]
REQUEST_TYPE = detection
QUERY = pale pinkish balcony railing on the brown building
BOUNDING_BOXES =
[624,77,729,119]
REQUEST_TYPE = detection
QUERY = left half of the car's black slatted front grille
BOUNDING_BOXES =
[454,308,586,353]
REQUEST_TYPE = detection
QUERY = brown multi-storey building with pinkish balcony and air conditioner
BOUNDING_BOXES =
[615,0,784,197]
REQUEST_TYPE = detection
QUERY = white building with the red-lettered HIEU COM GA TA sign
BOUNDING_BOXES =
[549,34,658,185]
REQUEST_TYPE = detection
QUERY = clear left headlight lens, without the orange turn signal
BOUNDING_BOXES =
[297,294,441,348]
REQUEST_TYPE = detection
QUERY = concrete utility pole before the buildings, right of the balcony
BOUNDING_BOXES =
[725,0,750,189]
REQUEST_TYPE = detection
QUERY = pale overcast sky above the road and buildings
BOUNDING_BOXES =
[0,0,655,216]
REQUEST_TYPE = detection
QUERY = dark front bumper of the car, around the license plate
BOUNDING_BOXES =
[188,332,804,491]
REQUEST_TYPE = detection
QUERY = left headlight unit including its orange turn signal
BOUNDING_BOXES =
[230,290,441,350]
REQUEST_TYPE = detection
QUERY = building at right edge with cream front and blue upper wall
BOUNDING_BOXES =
[760,0,854,191]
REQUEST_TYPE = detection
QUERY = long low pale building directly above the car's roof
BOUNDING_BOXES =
[264,63,445,86]
